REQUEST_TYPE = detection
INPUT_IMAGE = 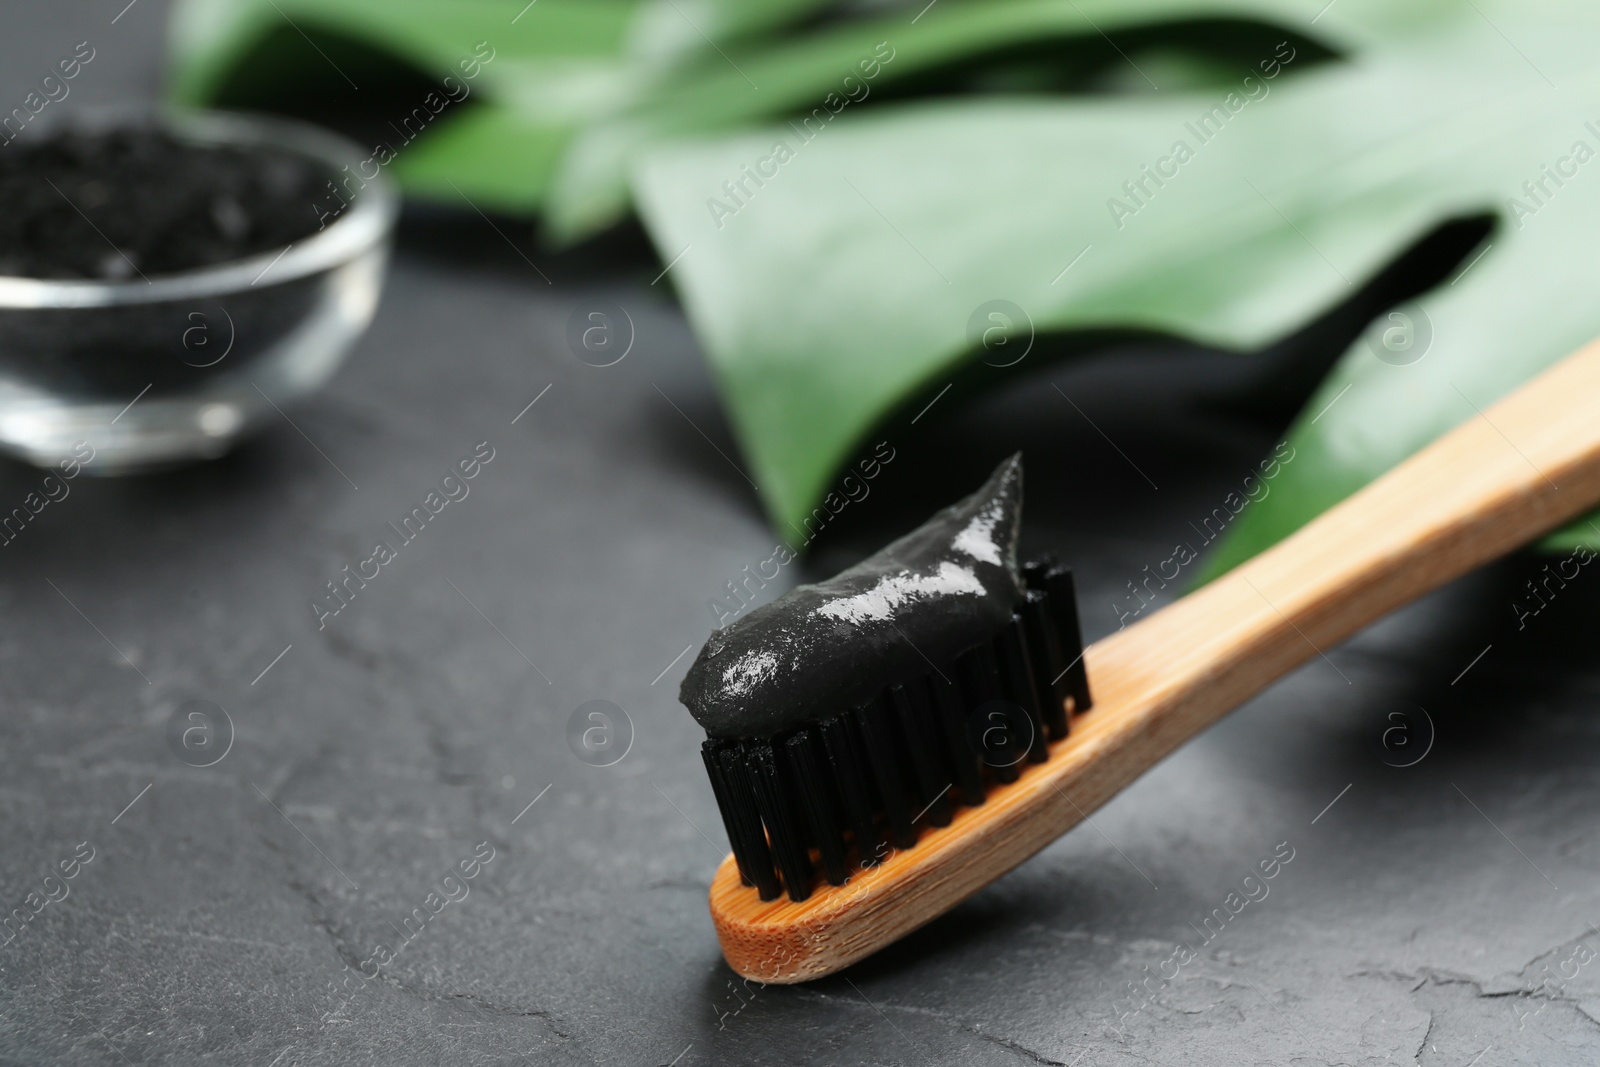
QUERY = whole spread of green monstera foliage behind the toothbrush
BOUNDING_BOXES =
[173,0,1600,573]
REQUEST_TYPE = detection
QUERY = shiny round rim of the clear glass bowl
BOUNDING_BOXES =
[0,106,400,309]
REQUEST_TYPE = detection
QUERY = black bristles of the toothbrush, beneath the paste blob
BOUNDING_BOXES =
[701,557,1090,901]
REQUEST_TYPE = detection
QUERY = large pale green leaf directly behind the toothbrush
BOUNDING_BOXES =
[620,0,1600,573]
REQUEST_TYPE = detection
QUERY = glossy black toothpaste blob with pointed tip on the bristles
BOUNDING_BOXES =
[678,453,1022,737]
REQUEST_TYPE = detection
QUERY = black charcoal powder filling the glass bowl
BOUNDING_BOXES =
[0,125,333,282]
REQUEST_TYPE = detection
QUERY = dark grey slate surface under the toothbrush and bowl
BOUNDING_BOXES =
[0,0,1600,1067]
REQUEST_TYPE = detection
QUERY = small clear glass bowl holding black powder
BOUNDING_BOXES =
[0,110,398,474]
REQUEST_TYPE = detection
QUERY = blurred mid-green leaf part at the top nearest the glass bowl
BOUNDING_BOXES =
[171,0,649,213]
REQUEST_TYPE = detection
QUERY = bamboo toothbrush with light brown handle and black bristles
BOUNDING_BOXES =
[685,335,1600,982]
